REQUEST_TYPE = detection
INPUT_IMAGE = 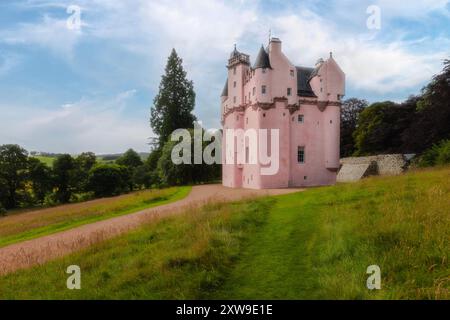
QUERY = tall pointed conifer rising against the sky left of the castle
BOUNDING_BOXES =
[150,49,196,148]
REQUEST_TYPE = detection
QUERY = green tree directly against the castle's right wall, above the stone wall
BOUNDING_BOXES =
[341,98,369,157]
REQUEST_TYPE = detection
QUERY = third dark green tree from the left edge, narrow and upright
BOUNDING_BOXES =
[53,154,77,203]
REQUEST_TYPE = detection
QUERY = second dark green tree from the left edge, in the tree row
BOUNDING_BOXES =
[27,158,53,203]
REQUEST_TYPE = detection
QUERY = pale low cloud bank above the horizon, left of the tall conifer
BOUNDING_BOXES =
[0,91,153,153]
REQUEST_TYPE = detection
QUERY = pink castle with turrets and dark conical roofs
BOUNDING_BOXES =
[221,38,345,189]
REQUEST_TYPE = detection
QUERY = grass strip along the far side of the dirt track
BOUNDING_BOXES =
[0,187,191,247]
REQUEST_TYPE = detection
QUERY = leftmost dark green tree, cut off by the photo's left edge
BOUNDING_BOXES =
[0,144,28,209]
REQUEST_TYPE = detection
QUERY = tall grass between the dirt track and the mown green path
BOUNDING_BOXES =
[0,199,272,299]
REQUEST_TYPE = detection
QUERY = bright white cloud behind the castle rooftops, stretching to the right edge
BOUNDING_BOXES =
[272,12,449,94]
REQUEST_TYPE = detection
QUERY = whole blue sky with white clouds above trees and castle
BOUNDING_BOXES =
[0,0,450,154]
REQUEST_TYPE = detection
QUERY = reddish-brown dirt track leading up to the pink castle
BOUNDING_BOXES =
[0,185,301,275]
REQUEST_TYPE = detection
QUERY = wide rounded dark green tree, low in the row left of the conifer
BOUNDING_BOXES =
[88,164,130,197]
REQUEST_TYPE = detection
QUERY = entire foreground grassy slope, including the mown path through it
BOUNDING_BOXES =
[0,167,450,299]
